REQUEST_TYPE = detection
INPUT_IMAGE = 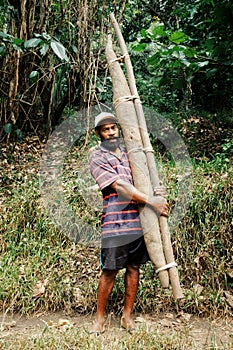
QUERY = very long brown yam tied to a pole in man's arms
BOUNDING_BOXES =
[106,14,183,299]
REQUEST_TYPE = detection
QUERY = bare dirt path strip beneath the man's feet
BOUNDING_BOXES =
[0,312,233,350]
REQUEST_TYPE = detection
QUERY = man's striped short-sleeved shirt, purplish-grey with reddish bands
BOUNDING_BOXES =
[90,147,142,241]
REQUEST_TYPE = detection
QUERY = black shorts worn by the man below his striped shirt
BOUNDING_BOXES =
[100,236,150,270]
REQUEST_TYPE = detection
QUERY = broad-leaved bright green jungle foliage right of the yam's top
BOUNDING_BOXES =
[127,0,233,112]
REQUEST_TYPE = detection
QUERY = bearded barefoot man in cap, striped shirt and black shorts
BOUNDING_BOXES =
[90,112,168,333]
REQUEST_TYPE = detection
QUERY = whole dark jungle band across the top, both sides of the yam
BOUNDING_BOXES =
[0,0,233,139]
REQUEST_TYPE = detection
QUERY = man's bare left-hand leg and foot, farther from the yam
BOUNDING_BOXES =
[91,270,118,333]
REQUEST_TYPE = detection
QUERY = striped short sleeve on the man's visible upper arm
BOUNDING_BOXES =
[90,153,120,190]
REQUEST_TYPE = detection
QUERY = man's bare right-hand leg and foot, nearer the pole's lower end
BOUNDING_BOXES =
[121,265,139,331]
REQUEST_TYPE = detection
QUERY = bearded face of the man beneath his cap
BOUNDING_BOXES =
[99,123,120,151]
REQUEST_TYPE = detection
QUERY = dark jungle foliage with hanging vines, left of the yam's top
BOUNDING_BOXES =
[0,0,126,135]
